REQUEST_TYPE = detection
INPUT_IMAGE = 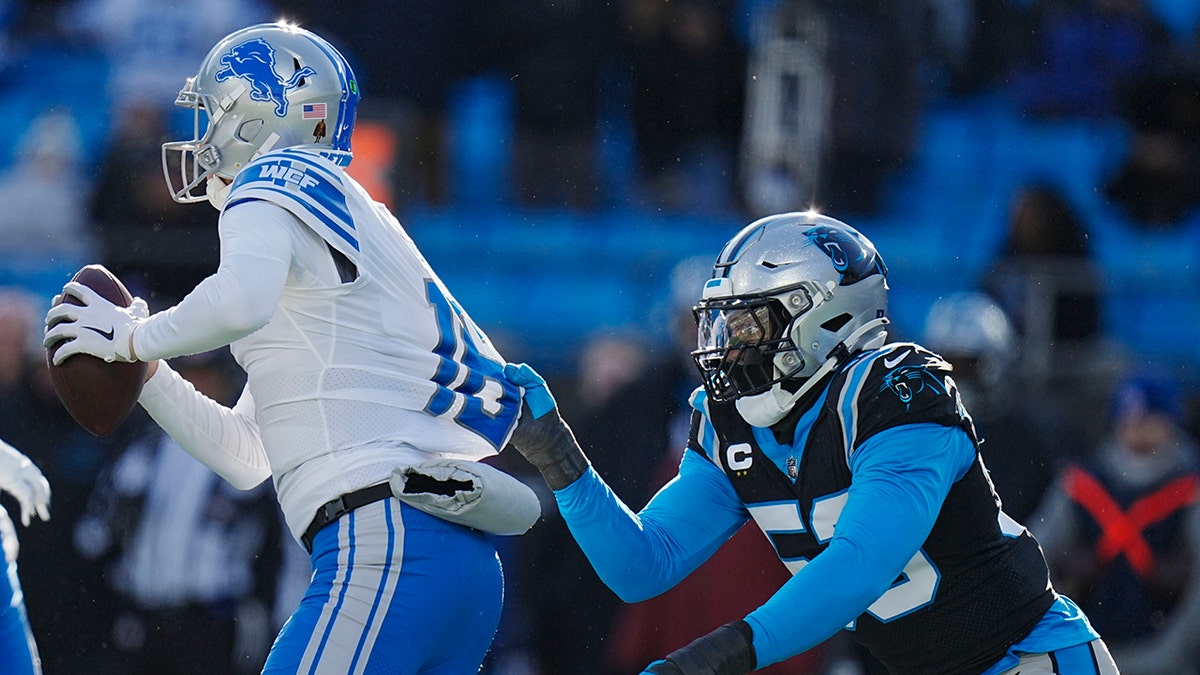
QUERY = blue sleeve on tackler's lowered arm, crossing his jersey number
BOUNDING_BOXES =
[746,424,976,668]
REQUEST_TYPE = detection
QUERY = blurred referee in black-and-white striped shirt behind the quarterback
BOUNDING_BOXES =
[73,352,290,675]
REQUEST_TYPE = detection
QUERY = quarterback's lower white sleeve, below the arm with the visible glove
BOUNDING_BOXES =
[138,362,271,490]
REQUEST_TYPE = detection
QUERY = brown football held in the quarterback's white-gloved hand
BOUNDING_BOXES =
[46,264,148,436]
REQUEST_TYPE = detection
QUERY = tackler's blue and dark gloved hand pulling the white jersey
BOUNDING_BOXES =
[504,363,588,490]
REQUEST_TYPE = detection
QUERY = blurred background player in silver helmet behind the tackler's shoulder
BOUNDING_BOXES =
[920,292,1084,522]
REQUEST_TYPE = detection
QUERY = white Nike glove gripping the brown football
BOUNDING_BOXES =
[42,281,150,365]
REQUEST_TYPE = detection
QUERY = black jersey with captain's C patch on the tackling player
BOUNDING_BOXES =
[689,344,1055,674]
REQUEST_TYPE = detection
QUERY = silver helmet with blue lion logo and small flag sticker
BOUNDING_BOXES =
[162,22,359,208]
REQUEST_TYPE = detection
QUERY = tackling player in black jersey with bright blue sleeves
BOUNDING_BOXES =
[505,211,1117,675]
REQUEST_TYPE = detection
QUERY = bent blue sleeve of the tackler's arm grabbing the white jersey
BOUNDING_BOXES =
[554,450,749,602]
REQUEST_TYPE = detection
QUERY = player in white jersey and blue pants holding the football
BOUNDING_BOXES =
[46,23,538,674]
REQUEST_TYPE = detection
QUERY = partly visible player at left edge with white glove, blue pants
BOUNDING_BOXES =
[0,440,50,675]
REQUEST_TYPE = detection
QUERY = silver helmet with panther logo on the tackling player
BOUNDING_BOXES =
[692,211,888,426]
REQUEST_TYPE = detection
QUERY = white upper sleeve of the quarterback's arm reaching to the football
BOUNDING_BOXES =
[133,201,302,362]
